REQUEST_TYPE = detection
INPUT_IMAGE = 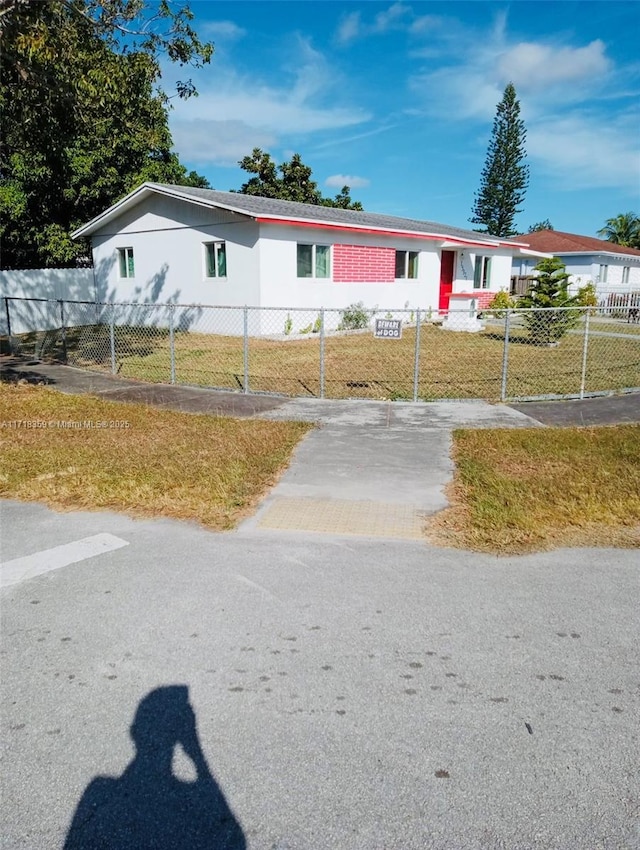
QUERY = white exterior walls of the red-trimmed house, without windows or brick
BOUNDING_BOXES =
[82,194,528,334]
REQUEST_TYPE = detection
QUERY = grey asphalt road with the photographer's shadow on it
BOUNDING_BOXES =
[0,502,640,850]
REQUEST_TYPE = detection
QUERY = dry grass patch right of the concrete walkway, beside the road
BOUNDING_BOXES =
[428,425,640,555]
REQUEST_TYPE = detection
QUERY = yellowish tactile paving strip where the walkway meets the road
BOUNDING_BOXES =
[258,498,424,540]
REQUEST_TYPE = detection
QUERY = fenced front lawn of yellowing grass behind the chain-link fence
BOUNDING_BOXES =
[10,320,640,401]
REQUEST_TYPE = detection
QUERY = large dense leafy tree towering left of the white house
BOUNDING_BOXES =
[0,0,213,268]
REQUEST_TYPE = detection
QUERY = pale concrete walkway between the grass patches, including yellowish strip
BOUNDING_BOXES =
[240,399,538,540]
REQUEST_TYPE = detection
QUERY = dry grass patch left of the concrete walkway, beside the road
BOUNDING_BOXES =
[0,384,312,530]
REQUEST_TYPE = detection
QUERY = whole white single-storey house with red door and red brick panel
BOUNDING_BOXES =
[73,183,539,332]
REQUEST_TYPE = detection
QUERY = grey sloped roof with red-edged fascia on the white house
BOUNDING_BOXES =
[72,183,527,253]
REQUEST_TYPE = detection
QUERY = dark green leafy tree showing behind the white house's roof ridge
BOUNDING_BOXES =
[238,148,362,210]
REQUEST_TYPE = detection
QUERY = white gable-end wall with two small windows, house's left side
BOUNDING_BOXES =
[93,196,260,333]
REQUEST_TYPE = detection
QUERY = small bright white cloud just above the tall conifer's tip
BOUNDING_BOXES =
[498,40,611,91]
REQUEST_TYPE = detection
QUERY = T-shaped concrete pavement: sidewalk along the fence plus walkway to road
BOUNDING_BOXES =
[3,358,640,541]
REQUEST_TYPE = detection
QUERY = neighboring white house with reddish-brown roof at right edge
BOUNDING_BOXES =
[512,230,640,297]
